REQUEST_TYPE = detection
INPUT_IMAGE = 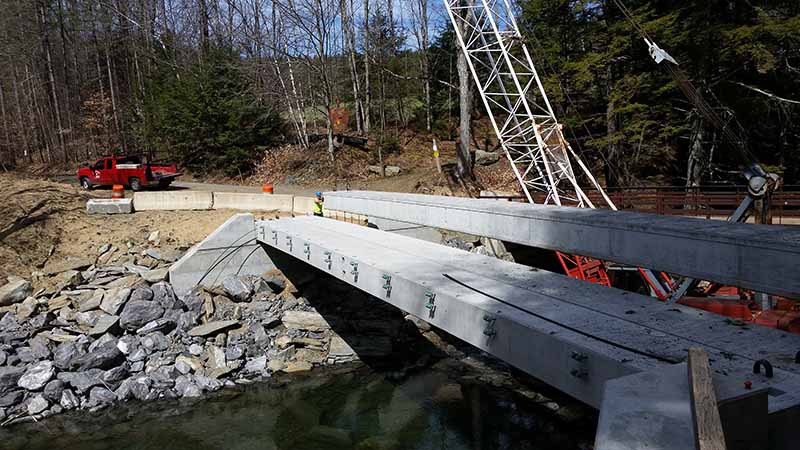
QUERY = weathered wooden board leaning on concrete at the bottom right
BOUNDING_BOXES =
[689,348,725,450]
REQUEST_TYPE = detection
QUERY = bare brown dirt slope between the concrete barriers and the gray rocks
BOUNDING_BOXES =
[0,174,241,284]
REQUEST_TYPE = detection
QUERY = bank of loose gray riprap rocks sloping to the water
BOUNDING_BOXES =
[0,230,428,425]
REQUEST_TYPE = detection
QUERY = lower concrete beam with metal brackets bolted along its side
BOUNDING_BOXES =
[256,217,800,418]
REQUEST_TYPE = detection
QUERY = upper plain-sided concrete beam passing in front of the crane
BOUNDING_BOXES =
[325,191,800,298]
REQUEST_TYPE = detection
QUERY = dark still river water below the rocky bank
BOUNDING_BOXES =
[0,369,592,450]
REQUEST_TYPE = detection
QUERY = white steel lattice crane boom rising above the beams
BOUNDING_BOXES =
[445,0,615,209]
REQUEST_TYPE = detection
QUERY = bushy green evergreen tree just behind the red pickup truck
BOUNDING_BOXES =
[140,49,283,176]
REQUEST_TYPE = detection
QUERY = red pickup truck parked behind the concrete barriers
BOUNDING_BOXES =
[78,156,181,191]
